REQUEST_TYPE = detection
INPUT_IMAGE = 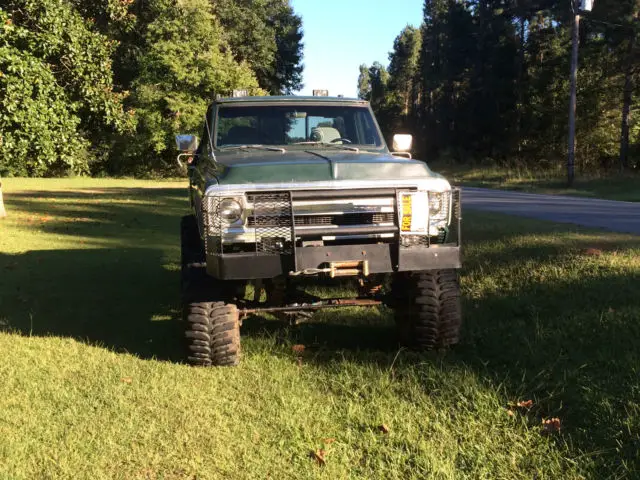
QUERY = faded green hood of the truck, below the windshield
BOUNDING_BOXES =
[212,149,442,185]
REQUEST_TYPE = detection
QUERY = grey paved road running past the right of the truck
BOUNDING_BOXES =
[462,186,640,235]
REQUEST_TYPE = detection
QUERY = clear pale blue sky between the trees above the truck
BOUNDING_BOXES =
[291,0,424,97]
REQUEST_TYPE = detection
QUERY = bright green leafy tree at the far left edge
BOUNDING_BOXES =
[0,0,132,175]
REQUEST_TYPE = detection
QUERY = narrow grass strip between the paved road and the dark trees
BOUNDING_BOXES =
[429,162,640,202]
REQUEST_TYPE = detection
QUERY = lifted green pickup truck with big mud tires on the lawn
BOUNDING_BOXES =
[176,96,461,365]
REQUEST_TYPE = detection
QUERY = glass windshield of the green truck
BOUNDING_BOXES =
[215,104,383,148]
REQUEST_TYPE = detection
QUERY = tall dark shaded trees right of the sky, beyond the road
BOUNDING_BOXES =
[358,0,640,170]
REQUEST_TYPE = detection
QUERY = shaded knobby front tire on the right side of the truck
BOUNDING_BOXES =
[391,270,462,350]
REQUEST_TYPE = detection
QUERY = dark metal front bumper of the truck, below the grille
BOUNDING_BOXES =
[207,244,462,280]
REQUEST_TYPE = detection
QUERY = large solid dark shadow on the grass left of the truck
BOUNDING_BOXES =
[0,249,182,360]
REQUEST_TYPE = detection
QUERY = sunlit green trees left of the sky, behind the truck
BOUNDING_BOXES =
[0,0,303,176]
